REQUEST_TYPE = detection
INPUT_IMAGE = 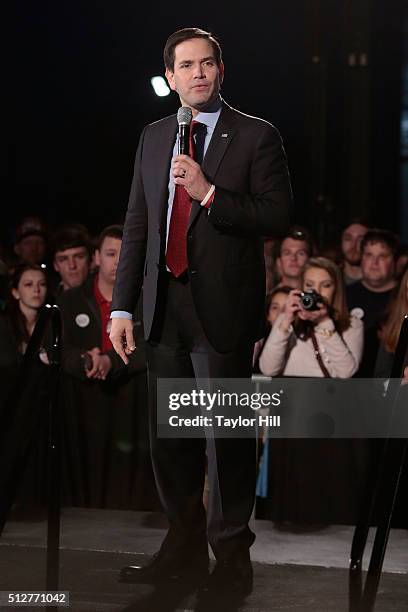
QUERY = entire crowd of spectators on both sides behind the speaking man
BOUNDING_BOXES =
[0,217,408,520]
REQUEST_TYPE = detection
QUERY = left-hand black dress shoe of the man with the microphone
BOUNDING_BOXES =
[120,552,209,584]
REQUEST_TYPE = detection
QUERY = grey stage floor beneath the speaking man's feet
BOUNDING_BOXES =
[0,508,408,612]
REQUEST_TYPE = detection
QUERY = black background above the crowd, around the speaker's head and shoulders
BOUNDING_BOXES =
[8,0,408,244]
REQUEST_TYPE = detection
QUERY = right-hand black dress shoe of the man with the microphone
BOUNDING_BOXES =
[200,554,253,598]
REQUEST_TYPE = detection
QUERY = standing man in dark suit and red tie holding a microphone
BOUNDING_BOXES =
[111,28,291,594]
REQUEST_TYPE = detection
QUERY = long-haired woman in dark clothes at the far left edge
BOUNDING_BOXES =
[0,264,49,507]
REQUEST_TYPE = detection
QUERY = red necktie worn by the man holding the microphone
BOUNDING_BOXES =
[166,121,202,277]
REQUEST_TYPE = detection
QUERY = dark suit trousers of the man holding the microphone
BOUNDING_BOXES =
[147,272,256,559]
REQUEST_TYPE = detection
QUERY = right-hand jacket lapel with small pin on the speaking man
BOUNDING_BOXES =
[189,102,236,229]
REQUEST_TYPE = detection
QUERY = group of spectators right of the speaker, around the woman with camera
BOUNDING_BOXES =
[255,219,408,378]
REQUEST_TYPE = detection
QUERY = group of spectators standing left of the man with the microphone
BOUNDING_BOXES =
[0,218,158,509]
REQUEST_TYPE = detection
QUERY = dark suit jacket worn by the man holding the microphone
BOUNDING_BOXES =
[112,103,291,352]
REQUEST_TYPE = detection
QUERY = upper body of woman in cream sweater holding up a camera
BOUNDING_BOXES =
[259,257,363,378]
